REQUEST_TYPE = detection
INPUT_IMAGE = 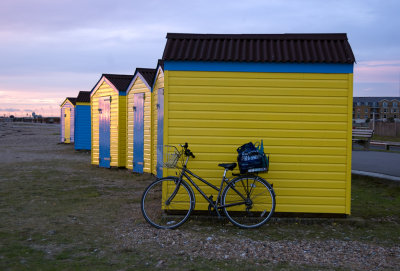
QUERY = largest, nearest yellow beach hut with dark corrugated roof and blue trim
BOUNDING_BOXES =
[158,34,355,215]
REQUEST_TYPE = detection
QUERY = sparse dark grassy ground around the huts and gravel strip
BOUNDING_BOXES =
[0,125,400,270]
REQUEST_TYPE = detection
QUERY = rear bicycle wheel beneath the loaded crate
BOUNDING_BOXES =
[222,176,275,229]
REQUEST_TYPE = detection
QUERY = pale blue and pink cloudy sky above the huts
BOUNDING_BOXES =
[0,0,400,116]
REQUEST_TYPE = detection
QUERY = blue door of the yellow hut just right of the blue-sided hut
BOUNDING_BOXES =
[99,97,111,168]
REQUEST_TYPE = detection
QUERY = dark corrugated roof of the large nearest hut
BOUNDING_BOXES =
[162,33,355,64]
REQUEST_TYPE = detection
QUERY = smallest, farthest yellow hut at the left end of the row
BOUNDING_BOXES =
[60,97,76,143]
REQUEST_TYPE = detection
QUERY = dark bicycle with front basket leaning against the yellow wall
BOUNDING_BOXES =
[141,143,276,229]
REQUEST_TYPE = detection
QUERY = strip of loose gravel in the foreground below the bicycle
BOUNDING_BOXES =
[115,223,400,270]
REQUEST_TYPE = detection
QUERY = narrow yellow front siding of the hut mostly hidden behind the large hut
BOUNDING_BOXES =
[151,68,164,176]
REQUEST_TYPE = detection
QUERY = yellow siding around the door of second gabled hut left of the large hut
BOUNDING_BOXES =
[126,76,152,173]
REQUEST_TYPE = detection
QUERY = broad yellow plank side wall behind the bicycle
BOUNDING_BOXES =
[164,71,353,214]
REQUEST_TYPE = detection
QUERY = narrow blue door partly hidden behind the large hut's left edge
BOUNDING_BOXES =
[157,88,164,178]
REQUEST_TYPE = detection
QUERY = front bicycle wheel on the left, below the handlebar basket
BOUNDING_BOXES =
[141,177,194,229]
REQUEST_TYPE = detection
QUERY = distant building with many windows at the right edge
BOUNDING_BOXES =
[353,97,400,123]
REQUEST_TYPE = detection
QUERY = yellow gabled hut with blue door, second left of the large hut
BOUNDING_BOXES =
[126,68,156,173]
